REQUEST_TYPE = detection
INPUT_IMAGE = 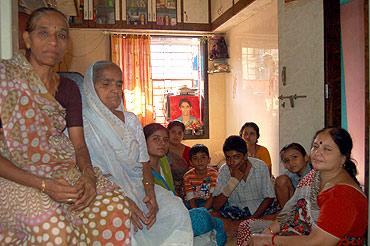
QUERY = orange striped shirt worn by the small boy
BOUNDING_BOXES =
[184,167,218,201]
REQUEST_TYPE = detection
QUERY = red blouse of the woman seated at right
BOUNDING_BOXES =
[317,184,368,245]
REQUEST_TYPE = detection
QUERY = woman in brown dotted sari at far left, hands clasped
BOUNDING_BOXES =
[0,8,131,245]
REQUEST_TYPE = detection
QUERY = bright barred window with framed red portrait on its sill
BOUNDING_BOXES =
[150,36,209,139]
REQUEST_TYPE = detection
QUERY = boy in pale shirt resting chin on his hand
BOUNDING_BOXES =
[213,136,276,220]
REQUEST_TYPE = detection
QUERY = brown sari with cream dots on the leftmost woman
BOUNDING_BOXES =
[0,55,131,245]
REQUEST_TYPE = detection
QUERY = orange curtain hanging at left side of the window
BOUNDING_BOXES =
[111,34,154,125]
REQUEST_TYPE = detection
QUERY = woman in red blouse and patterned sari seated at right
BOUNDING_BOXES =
[237,128,368,245]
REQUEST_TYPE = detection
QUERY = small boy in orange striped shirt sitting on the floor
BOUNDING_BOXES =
[184,144,217,209]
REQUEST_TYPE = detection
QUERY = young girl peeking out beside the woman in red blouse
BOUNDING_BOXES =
[275,143,312,208]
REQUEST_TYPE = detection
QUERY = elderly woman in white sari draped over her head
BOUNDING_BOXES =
[82,61,193,246]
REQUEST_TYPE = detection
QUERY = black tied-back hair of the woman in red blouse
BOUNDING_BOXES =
[312,127,360,185]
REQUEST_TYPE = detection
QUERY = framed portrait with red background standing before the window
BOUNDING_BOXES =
[168,95,204,135]
